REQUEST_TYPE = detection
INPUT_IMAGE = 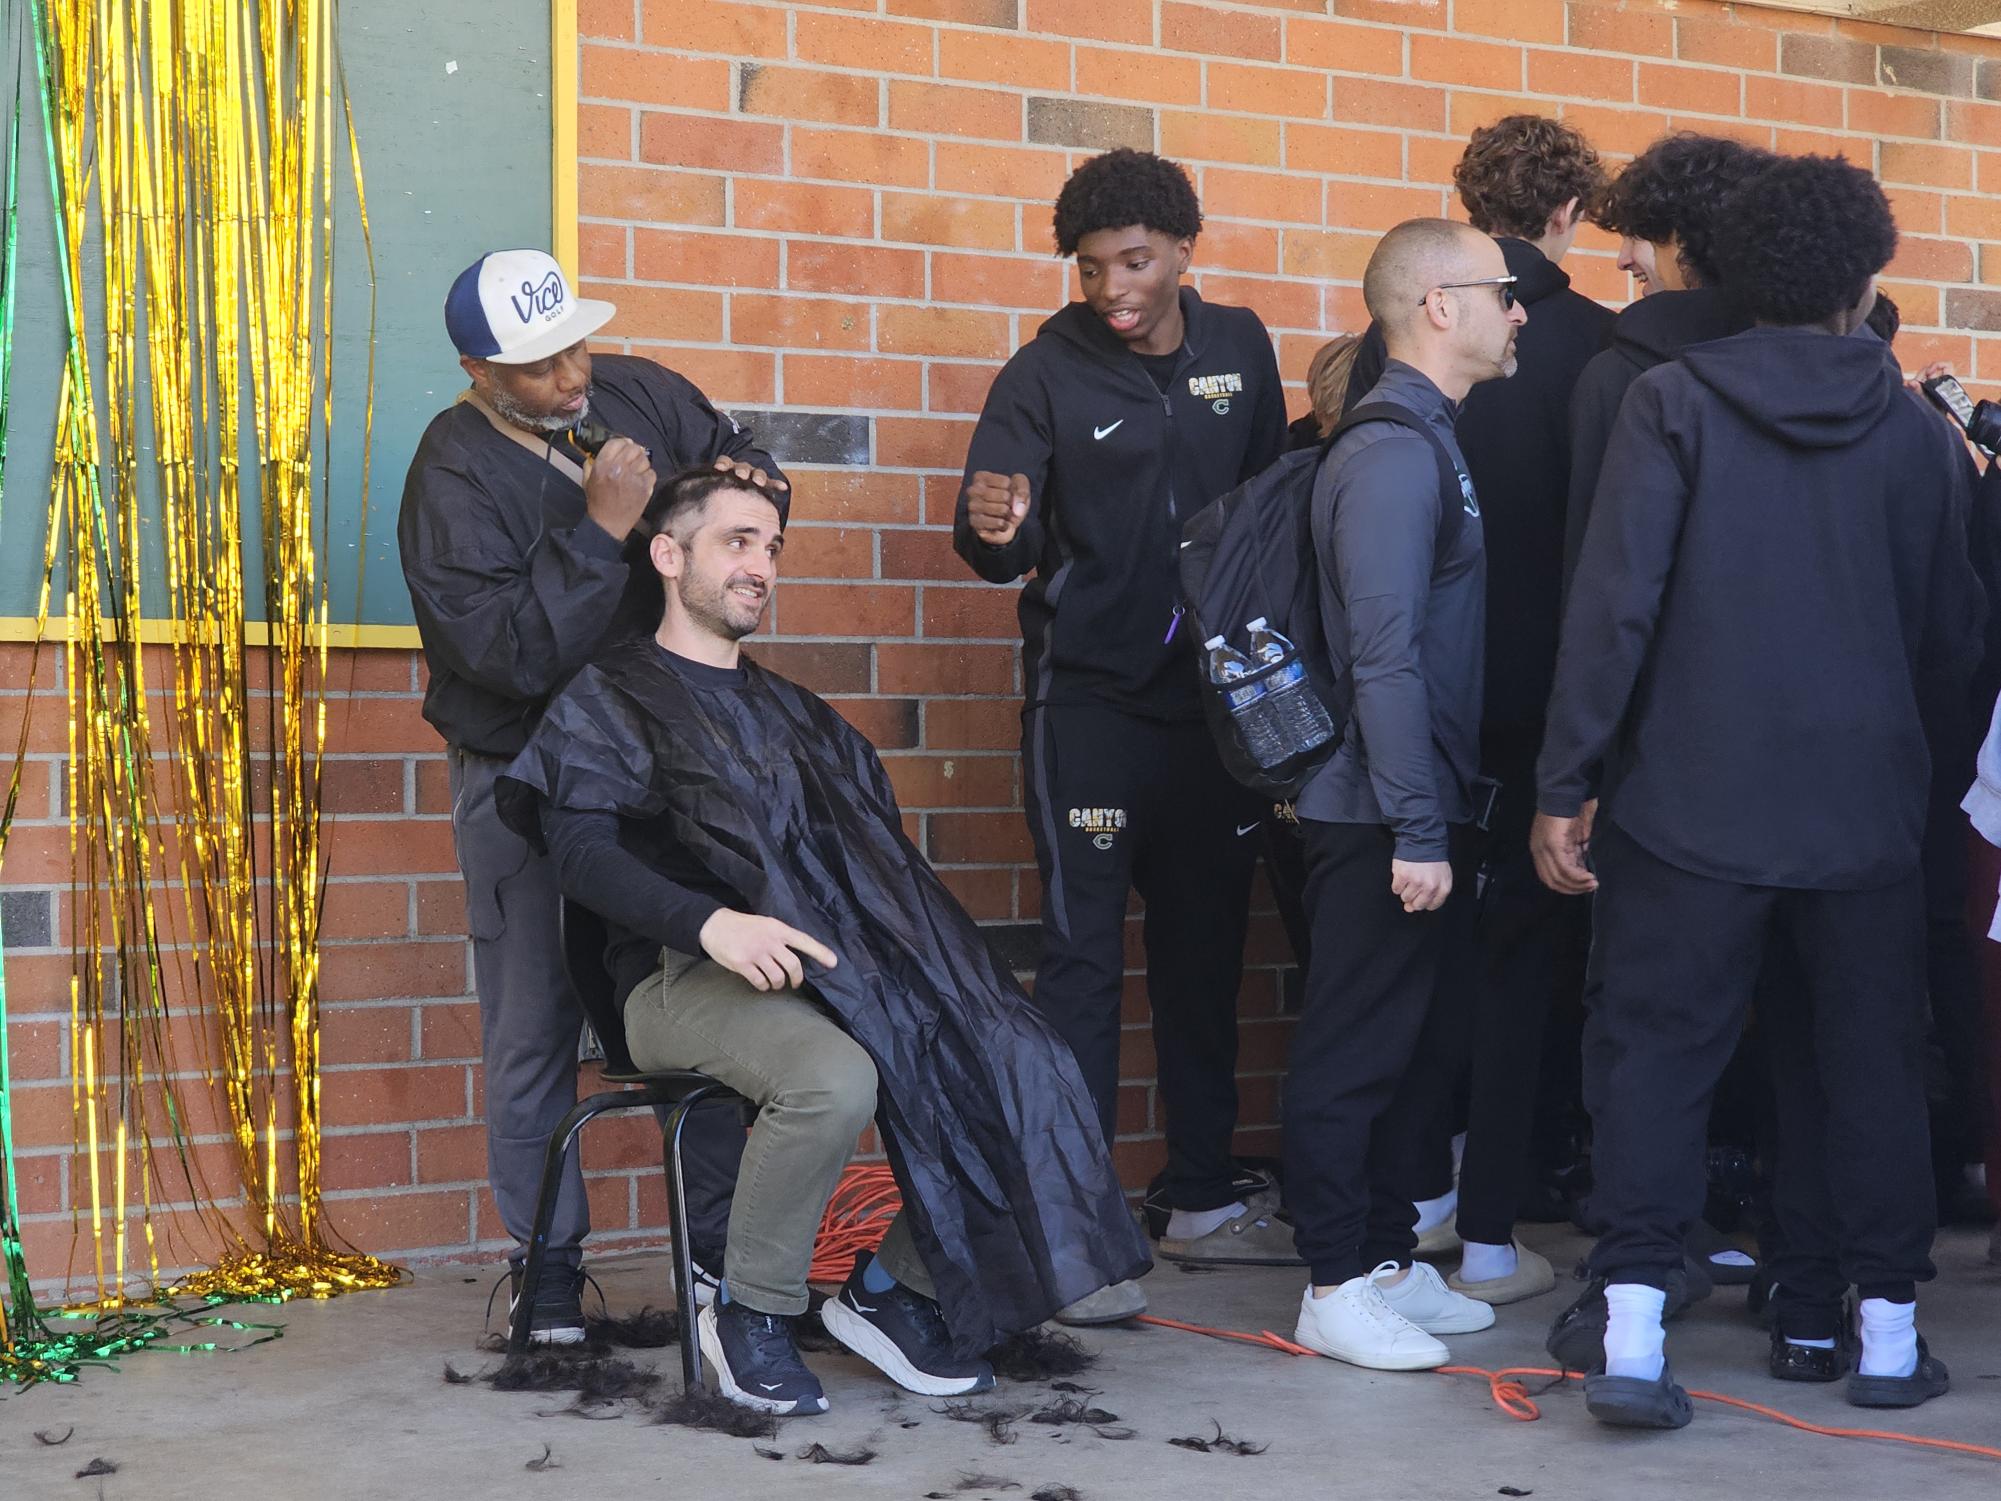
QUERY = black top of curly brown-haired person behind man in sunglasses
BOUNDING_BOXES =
[1349,250,1615,764]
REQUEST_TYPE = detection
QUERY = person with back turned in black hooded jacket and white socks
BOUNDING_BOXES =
[1533,156,1981,1427]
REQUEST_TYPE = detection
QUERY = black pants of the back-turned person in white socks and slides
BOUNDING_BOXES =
[1585,821,1937,1301]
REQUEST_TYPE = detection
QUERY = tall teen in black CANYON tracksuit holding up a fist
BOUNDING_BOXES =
[952,150,1293,1321]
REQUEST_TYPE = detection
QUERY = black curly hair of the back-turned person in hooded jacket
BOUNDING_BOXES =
[1715,156,1897,326]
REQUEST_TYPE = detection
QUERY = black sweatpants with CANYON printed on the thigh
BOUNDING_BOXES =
[1023,704,1267,1209]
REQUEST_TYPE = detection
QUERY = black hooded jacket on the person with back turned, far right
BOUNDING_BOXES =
[1537,328,1983,891]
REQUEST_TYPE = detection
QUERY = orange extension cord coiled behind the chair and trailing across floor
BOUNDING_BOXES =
[808,1163,2001,1459]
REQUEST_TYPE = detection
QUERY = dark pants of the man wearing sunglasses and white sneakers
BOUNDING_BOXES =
[1285,819,1475,1287]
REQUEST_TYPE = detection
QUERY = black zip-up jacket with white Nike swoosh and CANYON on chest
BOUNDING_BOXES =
[952,286,1285,720]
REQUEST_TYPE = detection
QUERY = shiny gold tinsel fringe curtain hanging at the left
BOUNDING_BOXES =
[0,0,398,1337]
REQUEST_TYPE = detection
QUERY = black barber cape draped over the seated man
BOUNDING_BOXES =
[496,640,1151,1357]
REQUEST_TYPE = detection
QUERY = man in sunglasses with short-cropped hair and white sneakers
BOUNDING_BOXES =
[1285,218,1527,1371]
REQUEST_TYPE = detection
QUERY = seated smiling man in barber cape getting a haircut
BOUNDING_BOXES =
[502,470,1147,1413]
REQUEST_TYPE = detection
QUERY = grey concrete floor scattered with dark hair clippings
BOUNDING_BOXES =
[0,1227,2001,1501]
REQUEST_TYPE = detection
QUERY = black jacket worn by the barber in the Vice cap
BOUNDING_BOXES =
[396,354,778,757]
